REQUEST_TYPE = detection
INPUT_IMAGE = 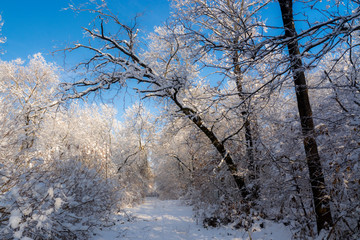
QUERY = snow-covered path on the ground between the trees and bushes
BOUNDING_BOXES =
[93,198,291,240]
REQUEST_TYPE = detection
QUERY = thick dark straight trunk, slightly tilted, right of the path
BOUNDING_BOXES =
[279,0,333,233]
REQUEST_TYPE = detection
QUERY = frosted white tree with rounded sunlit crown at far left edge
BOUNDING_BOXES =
[0,53,59,155]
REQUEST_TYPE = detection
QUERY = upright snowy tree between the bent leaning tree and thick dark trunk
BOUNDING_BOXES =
[173,0,267,180]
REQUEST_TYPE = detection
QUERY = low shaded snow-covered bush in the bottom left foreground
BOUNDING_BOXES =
[0,160,119,239]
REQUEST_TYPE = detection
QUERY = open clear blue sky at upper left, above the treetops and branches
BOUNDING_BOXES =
[0,0,169,65]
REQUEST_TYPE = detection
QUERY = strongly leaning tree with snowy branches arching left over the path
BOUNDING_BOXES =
[63,3,249,199]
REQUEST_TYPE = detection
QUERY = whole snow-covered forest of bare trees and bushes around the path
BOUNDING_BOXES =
[0,0,360,240]
